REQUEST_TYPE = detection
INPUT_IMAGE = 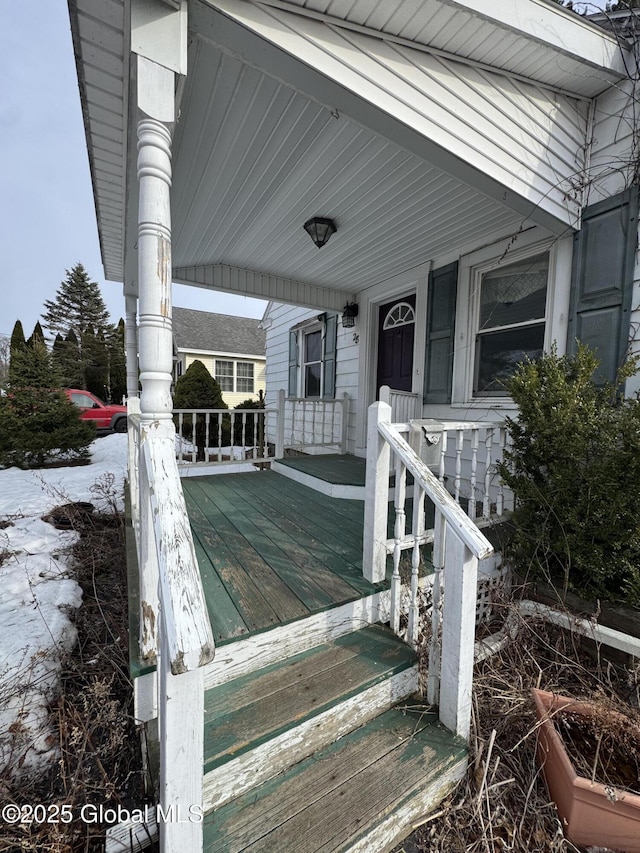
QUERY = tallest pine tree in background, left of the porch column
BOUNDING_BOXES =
[42,263,115,397]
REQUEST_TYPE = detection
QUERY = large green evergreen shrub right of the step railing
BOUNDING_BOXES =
[497,345,640,605]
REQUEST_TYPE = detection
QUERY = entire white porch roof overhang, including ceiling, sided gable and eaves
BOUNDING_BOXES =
[69,0,624,310]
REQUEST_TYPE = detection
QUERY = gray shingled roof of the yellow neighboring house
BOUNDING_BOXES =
[173,308,266,356]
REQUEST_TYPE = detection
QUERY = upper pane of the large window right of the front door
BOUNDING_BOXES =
[480,252,549,329]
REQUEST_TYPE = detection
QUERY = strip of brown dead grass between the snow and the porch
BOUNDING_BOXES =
[0,496,150,853]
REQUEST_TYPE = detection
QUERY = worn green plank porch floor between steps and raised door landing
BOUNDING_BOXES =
[182,471,387,644]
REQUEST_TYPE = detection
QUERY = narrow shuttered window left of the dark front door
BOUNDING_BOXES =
[289,314,338,399]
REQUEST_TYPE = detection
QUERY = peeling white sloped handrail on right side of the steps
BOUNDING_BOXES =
[378,421,493,560]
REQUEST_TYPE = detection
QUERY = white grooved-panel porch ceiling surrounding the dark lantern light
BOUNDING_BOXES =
[172,32,521,307]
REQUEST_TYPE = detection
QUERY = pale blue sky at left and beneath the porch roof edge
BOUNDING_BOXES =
[0,0,266,336]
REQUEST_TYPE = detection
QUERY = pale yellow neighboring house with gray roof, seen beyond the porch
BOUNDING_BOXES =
[173,308,265,409]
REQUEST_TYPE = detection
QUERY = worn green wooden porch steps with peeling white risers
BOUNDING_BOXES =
[199,625,466,853]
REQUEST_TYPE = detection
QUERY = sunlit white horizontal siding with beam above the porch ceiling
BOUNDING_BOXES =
[201,0,586,230]
